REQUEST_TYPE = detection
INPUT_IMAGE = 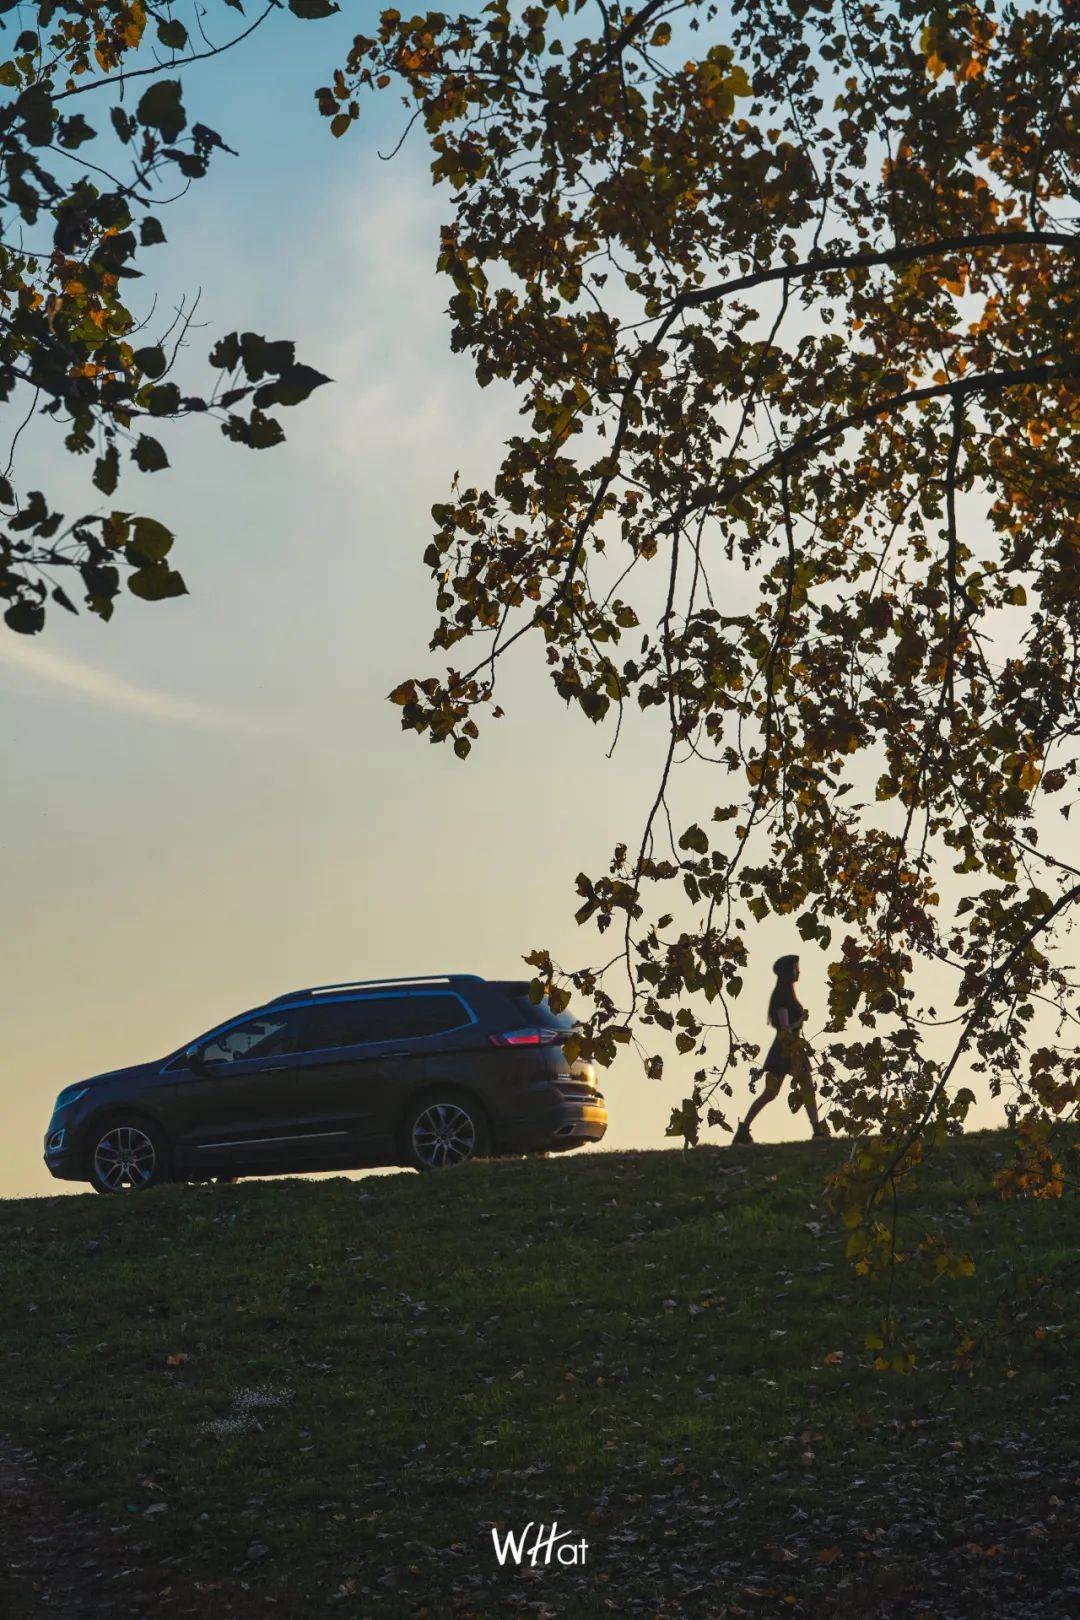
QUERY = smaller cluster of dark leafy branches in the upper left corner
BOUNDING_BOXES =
[0,0,337,633]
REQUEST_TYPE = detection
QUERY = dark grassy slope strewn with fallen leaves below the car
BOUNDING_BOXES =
[0,1132,1080,1620]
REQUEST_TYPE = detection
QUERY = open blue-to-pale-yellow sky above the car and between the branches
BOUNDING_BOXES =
[0,6,1029,1196]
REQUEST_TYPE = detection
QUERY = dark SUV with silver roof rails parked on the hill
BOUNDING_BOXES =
[45,974,607,1192]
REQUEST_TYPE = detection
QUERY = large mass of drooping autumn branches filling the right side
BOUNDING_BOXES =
[330,0,1080,1237]
